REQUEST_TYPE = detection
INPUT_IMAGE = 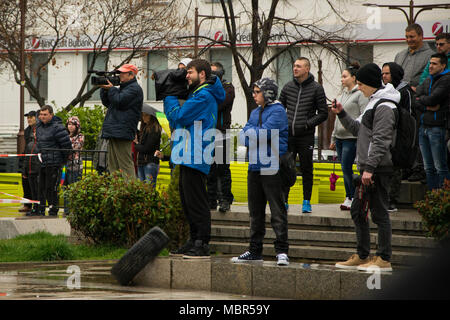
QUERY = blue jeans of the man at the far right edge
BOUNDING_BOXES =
[419,127,450,190]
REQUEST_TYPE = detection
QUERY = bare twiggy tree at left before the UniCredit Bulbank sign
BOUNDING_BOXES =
[0,0,187,111]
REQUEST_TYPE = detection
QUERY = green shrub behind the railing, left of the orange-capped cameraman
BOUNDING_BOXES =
[56,105,105,150]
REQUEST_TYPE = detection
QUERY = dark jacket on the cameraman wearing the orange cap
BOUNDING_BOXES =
[100,78,144,141]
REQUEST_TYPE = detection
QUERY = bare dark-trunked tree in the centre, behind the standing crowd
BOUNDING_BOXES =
[185,0,356,118]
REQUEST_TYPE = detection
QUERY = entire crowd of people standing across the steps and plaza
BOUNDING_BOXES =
[15,24,450,270]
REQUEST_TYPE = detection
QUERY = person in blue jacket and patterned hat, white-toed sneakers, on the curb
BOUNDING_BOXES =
[232,78,289,266]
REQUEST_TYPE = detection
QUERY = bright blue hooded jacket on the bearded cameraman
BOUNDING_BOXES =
[164,76,225,174]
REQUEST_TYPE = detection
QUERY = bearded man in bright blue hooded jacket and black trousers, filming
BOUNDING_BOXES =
[164,59,225,259]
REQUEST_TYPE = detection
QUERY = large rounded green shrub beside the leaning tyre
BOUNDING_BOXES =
[62,172,183,246]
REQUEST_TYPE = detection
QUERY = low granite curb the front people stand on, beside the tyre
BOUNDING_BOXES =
[133,257,394,300]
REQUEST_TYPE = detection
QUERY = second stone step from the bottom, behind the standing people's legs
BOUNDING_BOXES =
[211,225,436,252]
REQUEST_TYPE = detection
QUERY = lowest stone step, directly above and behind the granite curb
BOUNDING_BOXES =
[210,241,428,266]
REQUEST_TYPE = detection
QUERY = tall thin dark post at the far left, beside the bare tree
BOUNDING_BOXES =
[17,0,27,153]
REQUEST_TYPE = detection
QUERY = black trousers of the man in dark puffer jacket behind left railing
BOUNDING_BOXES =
[39,166,61,215]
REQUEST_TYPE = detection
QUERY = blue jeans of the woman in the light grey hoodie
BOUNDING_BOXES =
[336,139,356,199]
